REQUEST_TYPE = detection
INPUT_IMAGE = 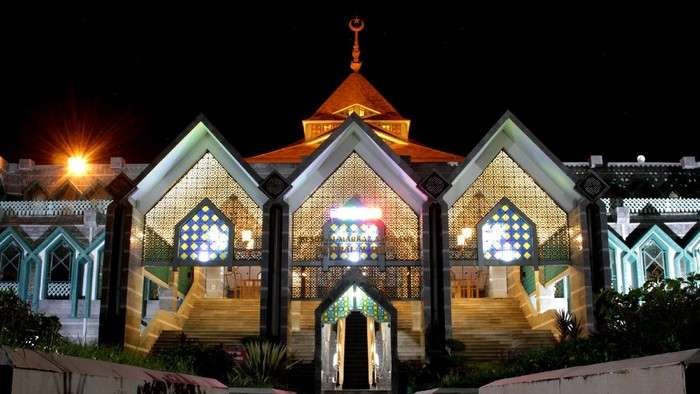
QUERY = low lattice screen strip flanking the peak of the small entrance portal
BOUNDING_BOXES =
[292,266,422,299]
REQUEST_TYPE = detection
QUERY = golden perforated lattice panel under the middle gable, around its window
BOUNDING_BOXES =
[292,152,420,262]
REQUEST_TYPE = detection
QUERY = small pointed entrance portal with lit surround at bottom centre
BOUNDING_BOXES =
[315,272,398,392]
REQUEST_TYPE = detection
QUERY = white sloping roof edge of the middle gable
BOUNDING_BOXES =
[284,122,427,214]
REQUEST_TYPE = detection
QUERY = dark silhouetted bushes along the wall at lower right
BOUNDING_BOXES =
[400,275,700,389]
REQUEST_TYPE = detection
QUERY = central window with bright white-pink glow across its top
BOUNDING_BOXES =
[323,198,384,265]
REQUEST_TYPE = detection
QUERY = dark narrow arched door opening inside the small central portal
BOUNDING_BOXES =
[343,311,369,389]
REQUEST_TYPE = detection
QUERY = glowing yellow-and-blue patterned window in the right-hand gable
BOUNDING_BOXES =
[477,198,537,263]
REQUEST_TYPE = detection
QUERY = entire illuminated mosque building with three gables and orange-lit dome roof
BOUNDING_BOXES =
[0,20,700,390]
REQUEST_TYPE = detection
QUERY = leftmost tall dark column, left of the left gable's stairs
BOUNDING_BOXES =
[98,198,133,346]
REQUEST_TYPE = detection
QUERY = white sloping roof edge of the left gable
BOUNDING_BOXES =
[130,115,267,213]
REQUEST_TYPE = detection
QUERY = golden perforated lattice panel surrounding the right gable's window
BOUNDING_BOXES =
[449,151,569,261]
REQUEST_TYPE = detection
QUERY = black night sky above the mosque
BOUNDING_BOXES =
[0,2,700,163]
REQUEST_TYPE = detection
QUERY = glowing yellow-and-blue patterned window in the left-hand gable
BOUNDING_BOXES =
[175,198,233,265]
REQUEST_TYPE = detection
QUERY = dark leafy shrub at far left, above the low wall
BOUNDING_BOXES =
[0,291,62,351]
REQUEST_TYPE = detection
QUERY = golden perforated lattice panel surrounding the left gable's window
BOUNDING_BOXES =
[143,153,262,263]
